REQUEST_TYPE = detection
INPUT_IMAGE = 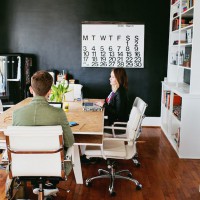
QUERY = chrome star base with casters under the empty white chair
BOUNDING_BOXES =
[85,160,142,196]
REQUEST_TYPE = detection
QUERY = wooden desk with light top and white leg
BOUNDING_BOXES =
[0,98,104,184]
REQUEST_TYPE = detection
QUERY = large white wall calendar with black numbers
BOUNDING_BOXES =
[82,23,144,68]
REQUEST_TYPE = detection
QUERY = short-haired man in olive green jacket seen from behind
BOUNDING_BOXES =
[10,71,74,197]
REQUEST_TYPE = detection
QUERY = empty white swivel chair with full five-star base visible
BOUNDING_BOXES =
[85,107,142,195]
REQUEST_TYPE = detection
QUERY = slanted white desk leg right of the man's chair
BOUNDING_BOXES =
[72,145,83,184]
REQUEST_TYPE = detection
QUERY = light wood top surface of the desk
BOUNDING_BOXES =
[0,98,104,134]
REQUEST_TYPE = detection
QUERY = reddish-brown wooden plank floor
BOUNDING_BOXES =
[0,128,200,200]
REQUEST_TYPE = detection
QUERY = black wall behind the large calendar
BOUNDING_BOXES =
[0,0,170,117]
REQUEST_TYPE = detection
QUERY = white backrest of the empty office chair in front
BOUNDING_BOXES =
[126,106,142,140]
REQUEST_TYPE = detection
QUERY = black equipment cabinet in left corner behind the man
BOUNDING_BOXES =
[0,53,34,108]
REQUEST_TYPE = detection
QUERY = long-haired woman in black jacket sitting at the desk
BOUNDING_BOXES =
[96,68,129,125]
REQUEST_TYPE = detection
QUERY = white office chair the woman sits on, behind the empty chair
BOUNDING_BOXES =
[104,97,148,167]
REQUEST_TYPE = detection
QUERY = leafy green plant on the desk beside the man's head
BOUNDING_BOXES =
[50,80,70,102]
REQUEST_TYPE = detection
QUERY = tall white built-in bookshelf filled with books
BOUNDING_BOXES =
[161,0,200,159]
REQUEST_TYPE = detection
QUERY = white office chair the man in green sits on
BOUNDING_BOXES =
[5,126,71,200]
